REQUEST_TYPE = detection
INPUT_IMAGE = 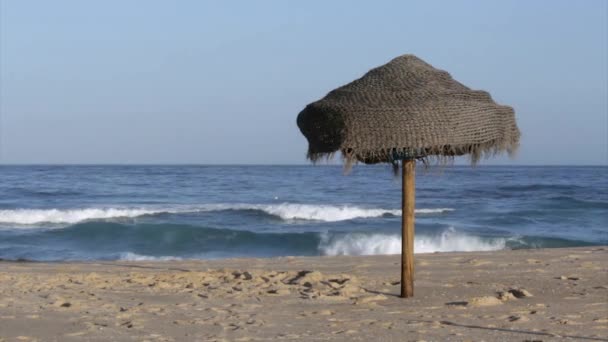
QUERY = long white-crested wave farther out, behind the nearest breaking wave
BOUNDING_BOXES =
[0,203,454,225]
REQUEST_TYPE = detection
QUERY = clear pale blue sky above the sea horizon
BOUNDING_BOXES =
[0,0,608,165]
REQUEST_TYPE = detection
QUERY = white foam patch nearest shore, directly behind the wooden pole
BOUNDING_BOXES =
[319,228,507,255]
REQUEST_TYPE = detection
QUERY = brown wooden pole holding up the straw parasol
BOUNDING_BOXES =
[401,159,416,298]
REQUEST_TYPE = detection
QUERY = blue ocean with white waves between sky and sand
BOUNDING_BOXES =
[0,165,608,261]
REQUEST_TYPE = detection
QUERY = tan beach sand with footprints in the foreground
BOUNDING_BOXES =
[0,247,608,341]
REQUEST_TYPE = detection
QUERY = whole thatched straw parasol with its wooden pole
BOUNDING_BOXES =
[297,55,520,297]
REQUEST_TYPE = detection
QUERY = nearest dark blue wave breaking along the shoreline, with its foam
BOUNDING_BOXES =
[0,222,592,261]
